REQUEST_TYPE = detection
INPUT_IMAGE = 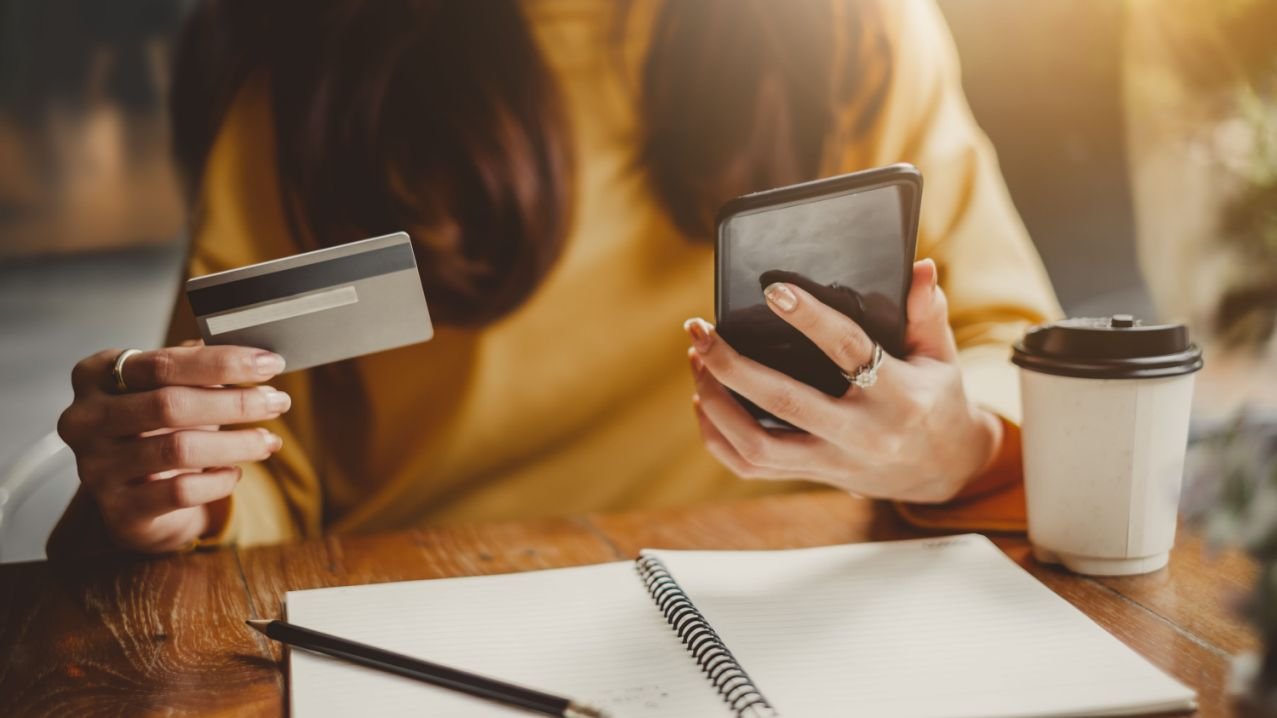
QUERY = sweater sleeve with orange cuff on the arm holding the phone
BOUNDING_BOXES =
[831,0,1061,523]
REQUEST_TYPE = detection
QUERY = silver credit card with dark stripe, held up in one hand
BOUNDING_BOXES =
[186,233,434,372]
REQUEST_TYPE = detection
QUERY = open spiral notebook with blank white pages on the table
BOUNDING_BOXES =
[286,535,1194,718]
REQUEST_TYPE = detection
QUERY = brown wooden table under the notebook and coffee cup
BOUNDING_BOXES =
[0,492,1258,715]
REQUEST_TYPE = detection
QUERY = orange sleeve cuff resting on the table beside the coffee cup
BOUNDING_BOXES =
[893,416,1027,531]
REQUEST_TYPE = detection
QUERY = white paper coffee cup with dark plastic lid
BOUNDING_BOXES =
[1013,314,1202,576]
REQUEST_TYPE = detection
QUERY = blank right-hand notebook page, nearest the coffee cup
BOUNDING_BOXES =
[644,535,1194,718]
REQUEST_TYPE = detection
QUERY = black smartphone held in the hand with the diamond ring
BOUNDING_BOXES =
[714,164,922,429]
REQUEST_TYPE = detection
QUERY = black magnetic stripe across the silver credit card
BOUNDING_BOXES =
[186,243,416,317]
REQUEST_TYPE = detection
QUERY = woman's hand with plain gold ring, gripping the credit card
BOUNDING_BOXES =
[57,345,291,552]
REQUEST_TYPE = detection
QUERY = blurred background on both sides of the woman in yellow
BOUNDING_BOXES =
[0,0,1277,560]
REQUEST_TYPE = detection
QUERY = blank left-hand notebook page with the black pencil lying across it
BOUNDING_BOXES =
[286,561,727,718]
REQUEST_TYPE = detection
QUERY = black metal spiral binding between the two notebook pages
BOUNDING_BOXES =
[636,556,778,718]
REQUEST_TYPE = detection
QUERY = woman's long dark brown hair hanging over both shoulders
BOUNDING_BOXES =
[172,0,889,325]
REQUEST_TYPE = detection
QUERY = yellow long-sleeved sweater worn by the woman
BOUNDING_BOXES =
[170,0,1057,543]
